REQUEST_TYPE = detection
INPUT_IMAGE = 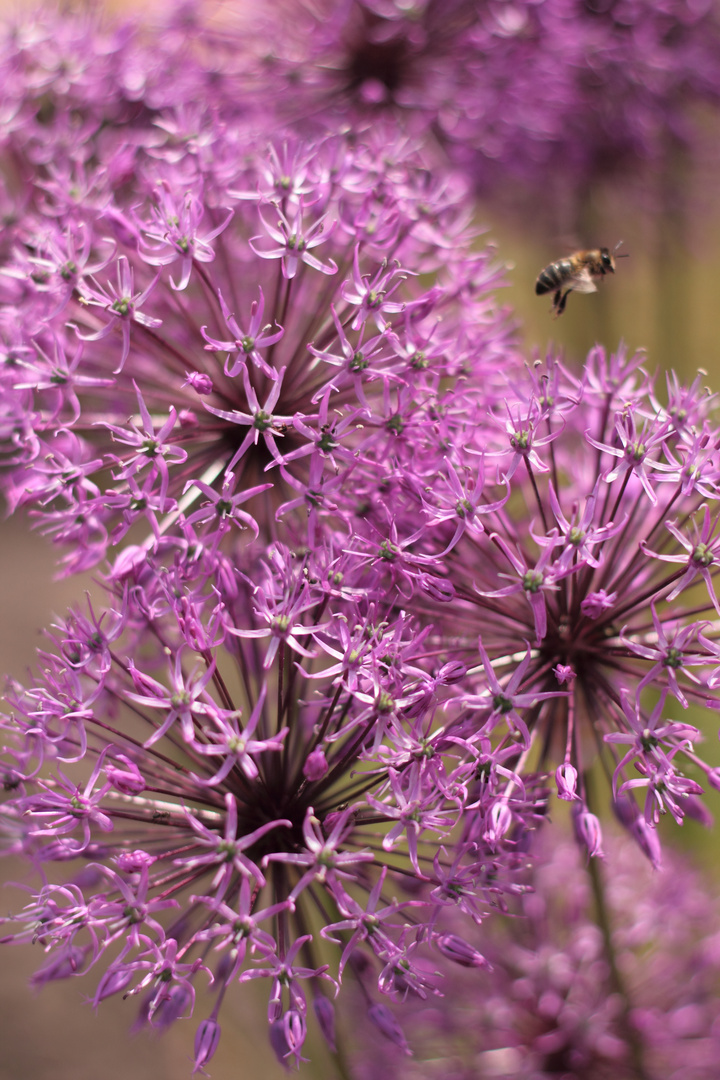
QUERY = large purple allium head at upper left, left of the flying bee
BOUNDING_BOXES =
[0,78,512,571]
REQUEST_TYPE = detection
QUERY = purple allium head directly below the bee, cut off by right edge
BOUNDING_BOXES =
[369,348,720,863]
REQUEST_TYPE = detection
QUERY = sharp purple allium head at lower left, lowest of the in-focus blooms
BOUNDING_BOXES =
[2,542,530,1070]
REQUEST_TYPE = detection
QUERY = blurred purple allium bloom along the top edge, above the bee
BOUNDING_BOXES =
[232,0,720,199]
